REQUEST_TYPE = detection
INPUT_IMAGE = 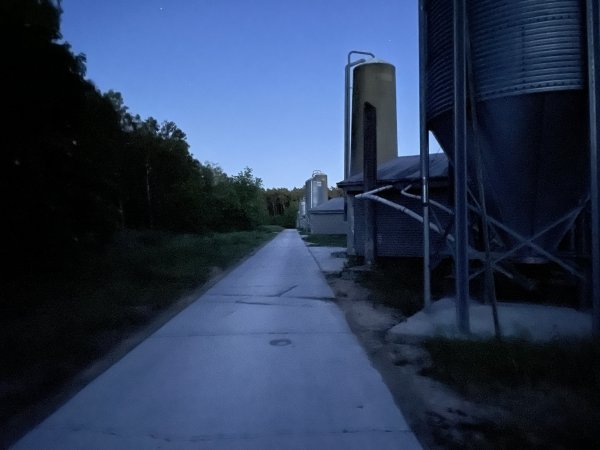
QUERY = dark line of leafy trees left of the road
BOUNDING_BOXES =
[0,0,344,274]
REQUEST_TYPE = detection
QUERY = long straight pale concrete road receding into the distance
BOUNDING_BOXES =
[13,230,421,450]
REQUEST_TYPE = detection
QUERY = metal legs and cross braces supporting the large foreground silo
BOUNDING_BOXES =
[419,0,600,335]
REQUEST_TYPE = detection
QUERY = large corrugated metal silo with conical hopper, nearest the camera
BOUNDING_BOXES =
[426,0,588,257]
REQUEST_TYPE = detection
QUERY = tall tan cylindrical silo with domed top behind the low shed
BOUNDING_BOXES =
[349,59,398,176]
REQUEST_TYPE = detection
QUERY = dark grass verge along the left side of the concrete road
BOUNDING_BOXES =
[0,227,281,438]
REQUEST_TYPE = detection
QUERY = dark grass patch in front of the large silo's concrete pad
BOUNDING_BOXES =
[422,338,600,449]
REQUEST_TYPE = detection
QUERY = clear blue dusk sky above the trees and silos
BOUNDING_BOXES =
[62,0,426,188]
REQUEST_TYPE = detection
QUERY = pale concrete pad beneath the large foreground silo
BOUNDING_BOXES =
[388,298,592,341]
